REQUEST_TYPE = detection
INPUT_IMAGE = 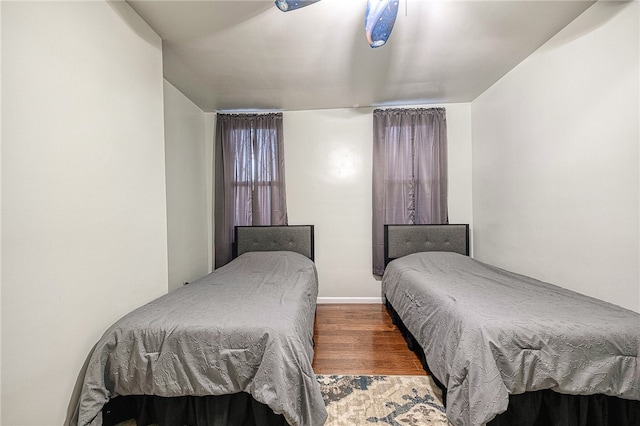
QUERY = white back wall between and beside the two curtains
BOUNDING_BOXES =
[284,104,471,302]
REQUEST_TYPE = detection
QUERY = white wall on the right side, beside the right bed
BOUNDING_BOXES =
[472,2,640,311]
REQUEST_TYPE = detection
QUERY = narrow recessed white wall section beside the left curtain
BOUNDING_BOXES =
[164,80,211,290]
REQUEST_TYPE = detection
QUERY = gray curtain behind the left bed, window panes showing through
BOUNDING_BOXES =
[214,113,287,268]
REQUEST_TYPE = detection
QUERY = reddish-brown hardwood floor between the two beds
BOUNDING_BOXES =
[313,304,426,376]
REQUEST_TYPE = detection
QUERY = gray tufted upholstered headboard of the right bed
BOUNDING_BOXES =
[384,224,469,265]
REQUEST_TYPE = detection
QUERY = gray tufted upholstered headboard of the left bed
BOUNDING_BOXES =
[233,225,314,260]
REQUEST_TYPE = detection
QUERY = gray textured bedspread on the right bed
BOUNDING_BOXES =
[382,252,640,425]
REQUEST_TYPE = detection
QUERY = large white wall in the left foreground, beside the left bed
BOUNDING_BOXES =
[0,1,167,425]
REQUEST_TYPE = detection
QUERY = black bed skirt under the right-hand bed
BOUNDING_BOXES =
[385,301,640,426]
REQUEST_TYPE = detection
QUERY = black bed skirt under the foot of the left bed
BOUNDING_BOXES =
[102,392,288,426]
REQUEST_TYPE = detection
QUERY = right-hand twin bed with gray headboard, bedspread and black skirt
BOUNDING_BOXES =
[382,225,640,426]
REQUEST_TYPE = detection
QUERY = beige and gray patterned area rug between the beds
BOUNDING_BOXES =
[316,375,449,426]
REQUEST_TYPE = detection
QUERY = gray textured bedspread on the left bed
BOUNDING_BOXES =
[78,252,327,426]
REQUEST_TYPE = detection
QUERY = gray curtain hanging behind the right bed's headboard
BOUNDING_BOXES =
[373,108,448,275]
